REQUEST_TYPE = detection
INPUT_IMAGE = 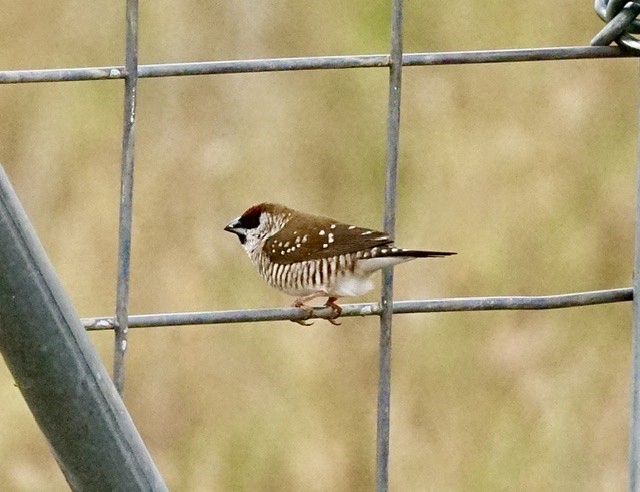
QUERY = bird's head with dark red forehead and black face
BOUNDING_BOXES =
[224,203,291,253]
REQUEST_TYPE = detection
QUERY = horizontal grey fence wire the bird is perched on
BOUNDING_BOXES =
[82,287,633,330]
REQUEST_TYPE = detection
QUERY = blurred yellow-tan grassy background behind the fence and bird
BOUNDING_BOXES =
[0,0,637,491]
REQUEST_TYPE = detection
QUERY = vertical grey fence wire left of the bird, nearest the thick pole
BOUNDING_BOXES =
[113,0,138,395]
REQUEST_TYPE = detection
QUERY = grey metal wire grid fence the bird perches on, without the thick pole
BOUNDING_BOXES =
[0,0,640,491]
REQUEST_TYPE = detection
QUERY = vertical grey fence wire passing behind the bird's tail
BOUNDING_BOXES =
[376,0,402,492]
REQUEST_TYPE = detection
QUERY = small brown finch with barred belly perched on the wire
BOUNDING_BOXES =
[224,203,456,325]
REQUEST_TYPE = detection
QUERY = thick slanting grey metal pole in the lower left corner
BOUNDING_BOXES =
[0,167,166,490]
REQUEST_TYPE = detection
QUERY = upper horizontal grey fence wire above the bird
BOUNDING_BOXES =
[0,46,634,84]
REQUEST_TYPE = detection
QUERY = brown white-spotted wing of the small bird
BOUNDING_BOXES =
[262,214,392,264]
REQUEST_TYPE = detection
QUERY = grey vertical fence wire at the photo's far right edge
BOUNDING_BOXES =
[629,62,640,492]
